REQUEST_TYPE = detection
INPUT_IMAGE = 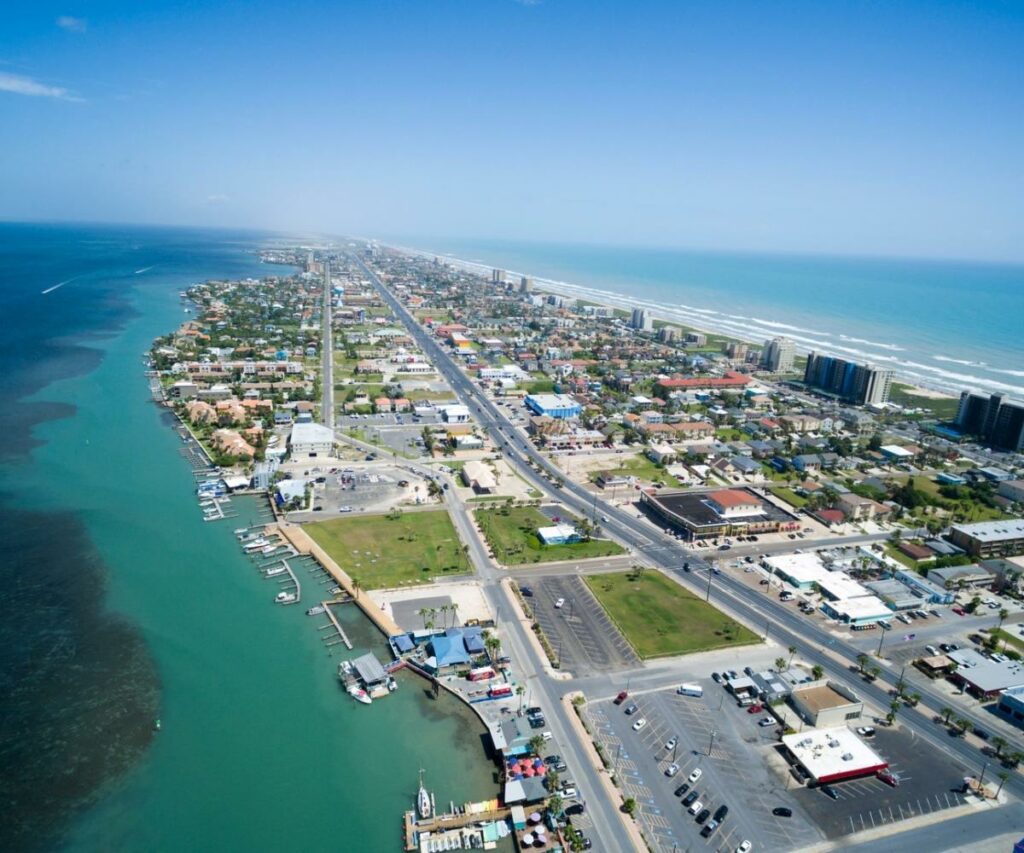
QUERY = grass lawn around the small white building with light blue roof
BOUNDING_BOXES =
[473,507,624,565]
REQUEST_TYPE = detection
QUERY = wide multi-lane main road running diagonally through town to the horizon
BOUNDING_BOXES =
[357,260,1024,849]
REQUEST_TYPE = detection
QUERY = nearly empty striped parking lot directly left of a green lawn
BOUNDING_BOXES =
[517,574,640,676]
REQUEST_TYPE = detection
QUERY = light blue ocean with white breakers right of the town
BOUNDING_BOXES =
[384,237,1024,398]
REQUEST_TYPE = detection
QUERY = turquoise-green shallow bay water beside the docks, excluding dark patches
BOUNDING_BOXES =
[4,226,497,851]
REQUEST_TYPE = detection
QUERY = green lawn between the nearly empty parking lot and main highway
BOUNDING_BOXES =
[585,568,760,658]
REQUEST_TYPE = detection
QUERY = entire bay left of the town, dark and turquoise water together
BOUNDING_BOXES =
[0,224,497,851]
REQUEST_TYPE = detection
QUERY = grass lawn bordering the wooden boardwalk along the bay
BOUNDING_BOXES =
[305,510,472,590]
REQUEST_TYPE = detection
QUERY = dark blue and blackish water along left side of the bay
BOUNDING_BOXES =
[0,224,276,850]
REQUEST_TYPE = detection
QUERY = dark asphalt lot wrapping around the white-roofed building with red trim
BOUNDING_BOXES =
[796,728,978,838]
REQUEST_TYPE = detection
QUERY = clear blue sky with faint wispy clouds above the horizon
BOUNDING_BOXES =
[0,0,1024,261]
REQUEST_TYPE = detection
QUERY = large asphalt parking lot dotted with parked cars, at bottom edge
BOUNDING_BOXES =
[587,680,821,853]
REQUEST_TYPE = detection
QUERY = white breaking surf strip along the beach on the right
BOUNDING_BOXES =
[380,237,999,399]
